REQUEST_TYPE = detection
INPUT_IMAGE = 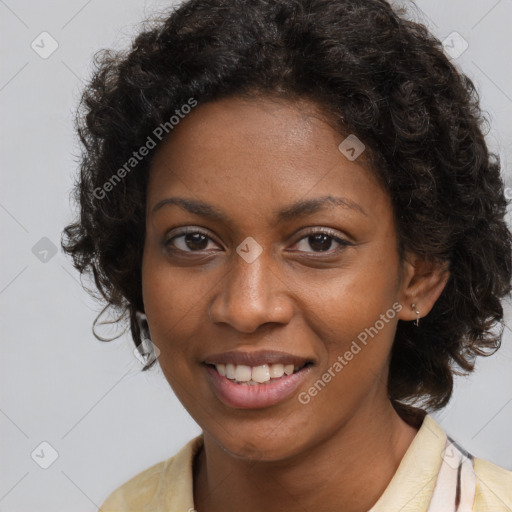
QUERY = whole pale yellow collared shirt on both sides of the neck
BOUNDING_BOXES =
[99,414,512,512]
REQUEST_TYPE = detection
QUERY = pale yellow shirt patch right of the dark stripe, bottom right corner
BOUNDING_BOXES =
[474,458,512,511]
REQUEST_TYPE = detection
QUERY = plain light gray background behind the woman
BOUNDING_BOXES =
[0,0,512,512]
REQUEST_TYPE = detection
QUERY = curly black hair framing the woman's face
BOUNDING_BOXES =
[61,0,512,410]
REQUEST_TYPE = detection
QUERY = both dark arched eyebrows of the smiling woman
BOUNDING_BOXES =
[152,196,368,224]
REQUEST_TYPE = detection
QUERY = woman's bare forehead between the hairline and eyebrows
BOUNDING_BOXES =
[148,98,389,224]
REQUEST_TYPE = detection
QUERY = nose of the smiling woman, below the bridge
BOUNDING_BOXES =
[209,251,294,333]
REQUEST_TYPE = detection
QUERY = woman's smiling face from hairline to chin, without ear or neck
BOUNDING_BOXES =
[142,98,410,460]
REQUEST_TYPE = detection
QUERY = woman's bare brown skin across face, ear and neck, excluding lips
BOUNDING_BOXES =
[142,97,448,512]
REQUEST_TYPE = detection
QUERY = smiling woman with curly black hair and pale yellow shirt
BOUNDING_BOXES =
[63,0,512,512]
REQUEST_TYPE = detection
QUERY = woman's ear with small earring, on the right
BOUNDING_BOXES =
[398,253,450,321]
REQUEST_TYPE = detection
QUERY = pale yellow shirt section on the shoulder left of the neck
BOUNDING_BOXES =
[99,436,203,512]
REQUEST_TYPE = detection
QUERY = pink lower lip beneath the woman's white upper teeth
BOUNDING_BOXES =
[205,366,310,409]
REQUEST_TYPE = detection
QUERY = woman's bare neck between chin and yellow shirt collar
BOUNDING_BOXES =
[194,401,417,512]
